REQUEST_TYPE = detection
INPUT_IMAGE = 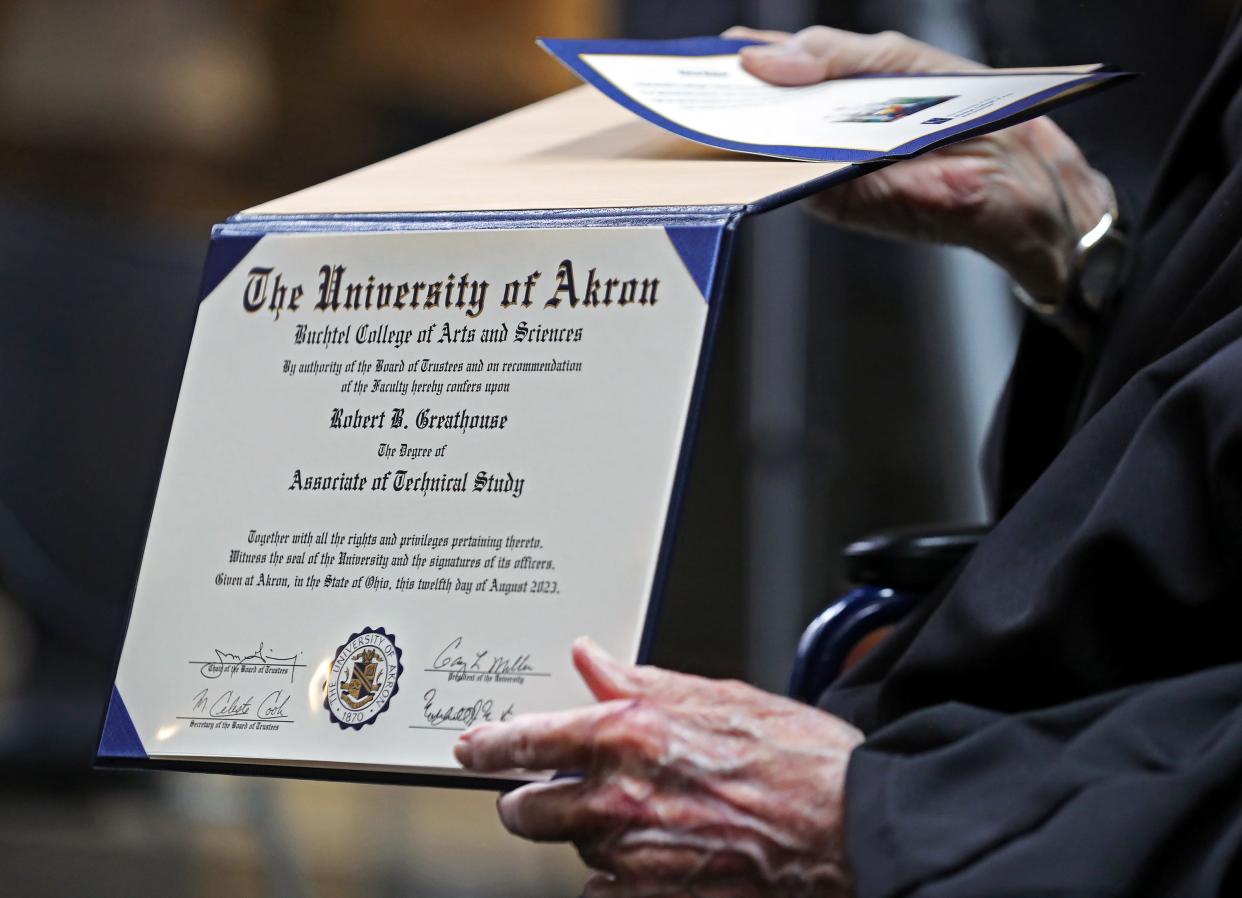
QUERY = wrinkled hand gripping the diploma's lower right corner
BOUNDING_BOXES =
[456,640,862,898]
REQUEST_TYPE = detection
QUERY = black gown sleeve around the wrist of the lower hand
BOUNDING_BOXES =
[846,664,1242,898]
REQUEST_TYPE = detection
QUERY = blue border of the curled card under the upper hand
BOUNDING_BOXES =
[538,37,1133,164]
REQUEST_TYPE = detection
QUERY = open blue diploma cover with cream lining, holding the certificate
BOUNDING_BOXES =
[98,39,1127,787]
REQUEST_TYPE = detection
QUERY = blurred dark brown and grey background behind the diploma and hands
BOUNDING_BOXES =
[0,0,1230,898]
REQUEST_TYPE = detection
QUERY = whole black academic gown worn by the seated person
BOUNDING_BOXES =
[821,21,1242,898]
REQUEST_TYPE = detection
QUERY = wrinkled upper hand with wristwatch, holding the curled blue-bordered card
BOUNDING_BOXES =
[724,26,1115,304]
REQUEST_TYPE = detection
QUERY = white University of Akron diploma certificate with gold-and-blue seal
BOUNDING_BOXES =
[104,226,722,776]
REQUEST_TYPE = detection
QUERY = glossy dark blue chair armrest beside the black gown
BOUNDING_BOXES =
[789,525,987,704]
